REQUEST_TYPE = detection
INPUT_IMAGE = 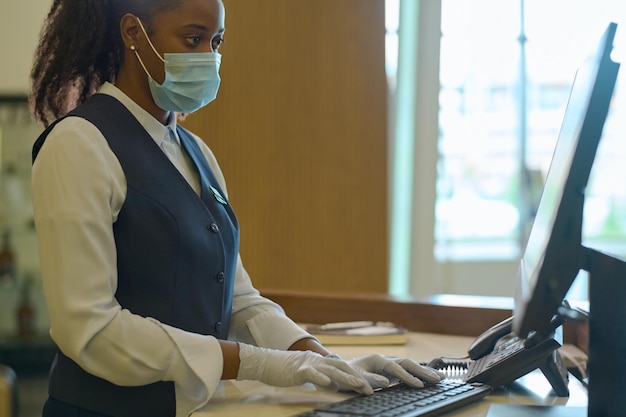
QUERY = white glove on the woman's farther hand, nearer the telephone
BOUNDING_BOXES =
[348,355,446,389]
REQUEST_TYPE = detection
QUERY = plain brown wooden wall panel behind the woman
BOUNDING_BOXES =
[185,0,388,292]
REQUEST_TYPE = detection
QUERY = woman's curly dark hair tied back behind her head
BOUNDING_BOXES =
[30,0,183,126]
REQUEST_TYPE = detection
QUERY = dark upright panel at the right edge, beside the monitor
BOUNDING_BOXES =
[583,247,626,417]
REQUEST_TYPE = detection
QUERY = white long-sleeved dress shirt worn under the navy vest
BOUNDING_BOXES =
[32,83,310,417]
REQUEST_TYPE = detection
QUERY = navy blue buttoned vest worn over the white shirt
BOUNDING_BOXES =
[33,94,239,417]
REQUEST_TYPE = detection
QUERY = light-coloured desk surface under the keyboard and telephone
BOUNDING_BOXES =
[193,332,587,417]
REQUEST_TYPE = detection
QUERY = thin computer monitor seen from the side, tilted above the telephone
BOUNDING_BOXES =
[513,23,619,338]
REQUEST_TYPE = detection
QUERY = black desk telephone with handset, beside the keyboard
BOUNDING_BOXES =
[463,316,569,397]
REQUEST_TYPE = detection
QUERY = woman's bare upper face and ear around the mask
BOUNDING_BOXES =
[132,0,224,83]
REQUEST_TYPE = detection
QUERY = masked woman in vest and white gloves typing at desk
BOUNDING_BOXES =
[32,0,441,417]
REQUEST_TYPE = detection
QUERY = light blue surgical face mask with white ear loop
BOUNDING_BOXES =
[131,18,222,113]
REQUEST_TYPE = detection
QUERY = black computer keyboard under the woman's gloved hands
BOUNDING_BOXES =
[294,380,491,417]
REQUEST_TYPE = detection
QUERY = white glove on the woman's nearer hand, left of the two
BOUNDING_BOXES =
[237,343,373,394]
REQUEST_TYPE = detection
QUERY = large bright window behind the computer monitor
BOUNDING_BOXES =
[387,0,626,296]
